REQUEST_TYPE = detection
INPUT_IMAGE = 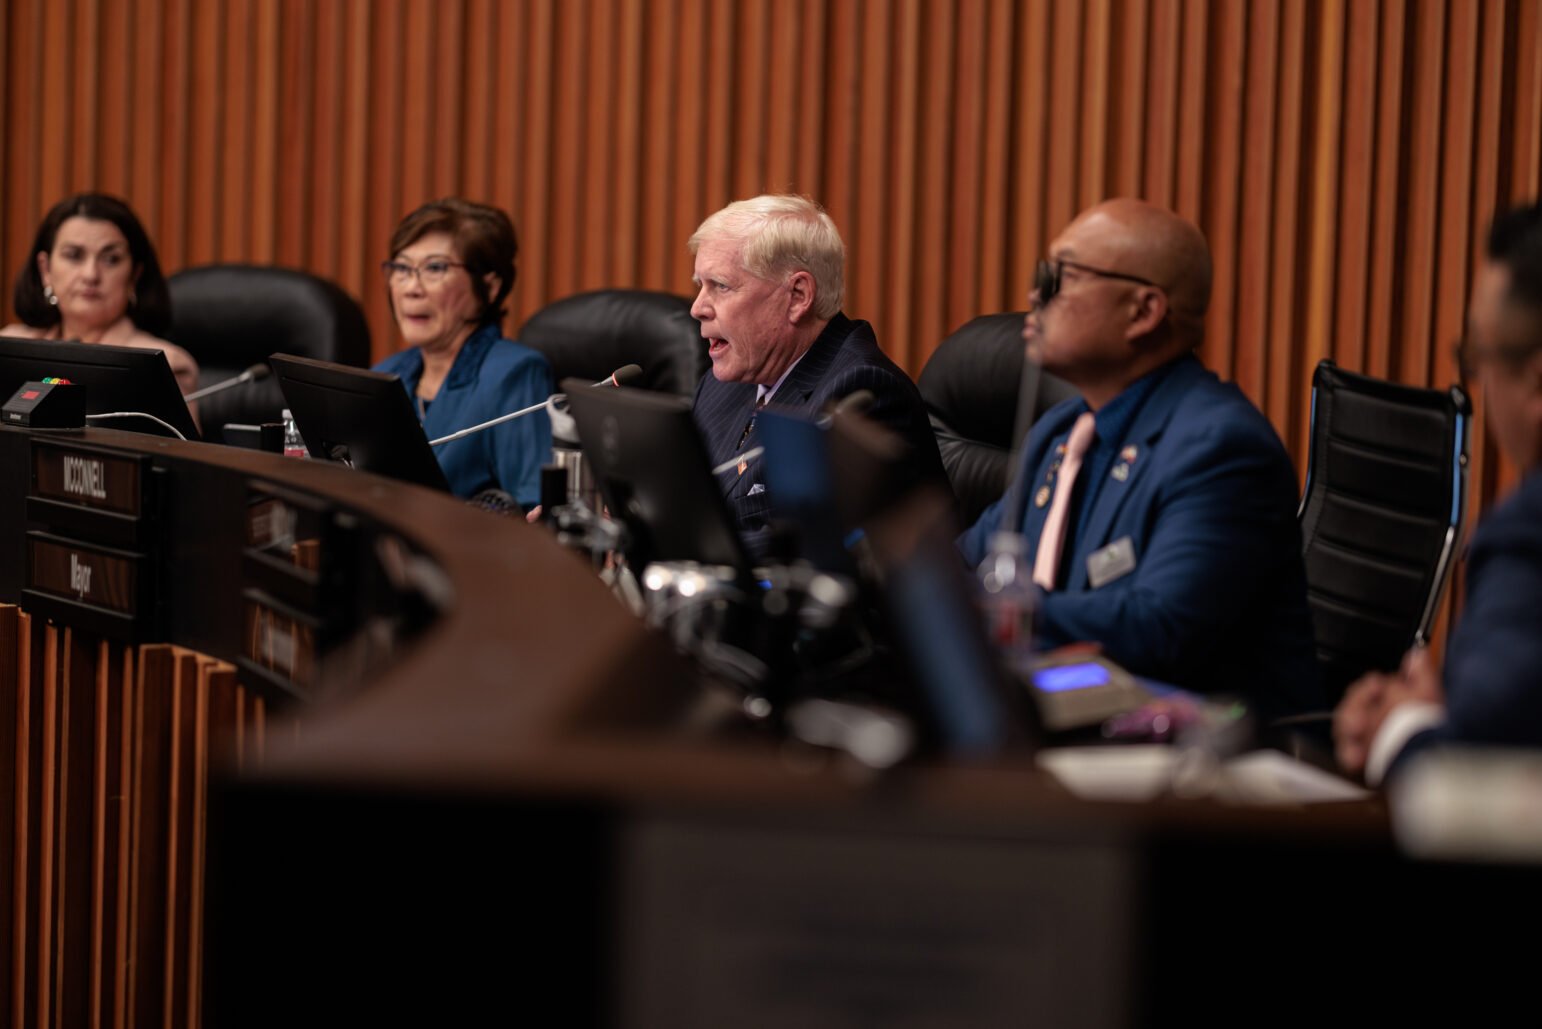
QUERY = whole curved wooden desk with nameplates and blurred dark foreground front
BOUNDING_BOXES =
[0,429,1542,1027]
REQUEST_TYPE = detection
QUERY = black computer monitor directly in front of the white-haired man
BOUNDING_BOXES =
[561,378,751,572]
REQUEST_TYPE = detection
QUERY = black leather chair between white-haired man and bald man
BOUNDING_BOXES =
[916,312,1076,525]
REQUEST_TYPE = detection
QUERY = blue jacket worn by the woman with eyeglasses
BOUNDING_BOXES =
[375,326,552,509]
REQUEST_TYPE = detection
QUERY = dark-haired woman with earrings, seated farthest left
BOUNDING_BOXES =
[0,193,197,393]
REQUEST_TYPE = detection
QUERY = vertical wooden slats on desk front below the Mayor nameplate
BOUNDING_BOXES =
[0,605,264,1026]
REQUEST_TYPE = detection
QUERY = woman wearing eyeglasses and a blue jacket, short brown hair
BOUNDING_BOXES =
[375,197,552,509]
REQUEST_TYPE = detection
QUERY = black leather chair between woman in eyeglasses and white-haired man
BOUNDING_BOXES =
[518,290,711,396]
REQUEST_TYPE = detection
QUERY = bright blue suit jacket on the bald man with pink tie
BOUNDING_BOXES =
[959,356,1321,717]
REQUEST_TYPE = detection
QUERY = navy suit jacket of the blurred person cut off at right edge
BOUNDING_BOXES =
[1392,472,1542,773]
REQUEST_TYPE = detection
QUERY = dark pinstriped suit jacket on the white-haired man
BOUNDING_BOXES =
[694,313,947,558]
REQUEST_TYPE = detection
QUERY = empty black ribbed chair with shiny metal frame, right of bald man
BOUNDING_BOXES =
[1300,361,1473,702]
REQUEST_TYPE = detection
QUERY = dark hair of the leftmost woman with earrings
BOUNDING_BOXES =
[11,193,171,336]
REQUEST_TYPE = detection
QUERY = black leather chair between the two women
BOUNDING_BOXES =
[167,264,370,441]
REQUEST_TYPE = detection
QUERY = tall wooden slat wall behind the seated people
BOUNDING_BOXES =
[0,0,1542,498]
